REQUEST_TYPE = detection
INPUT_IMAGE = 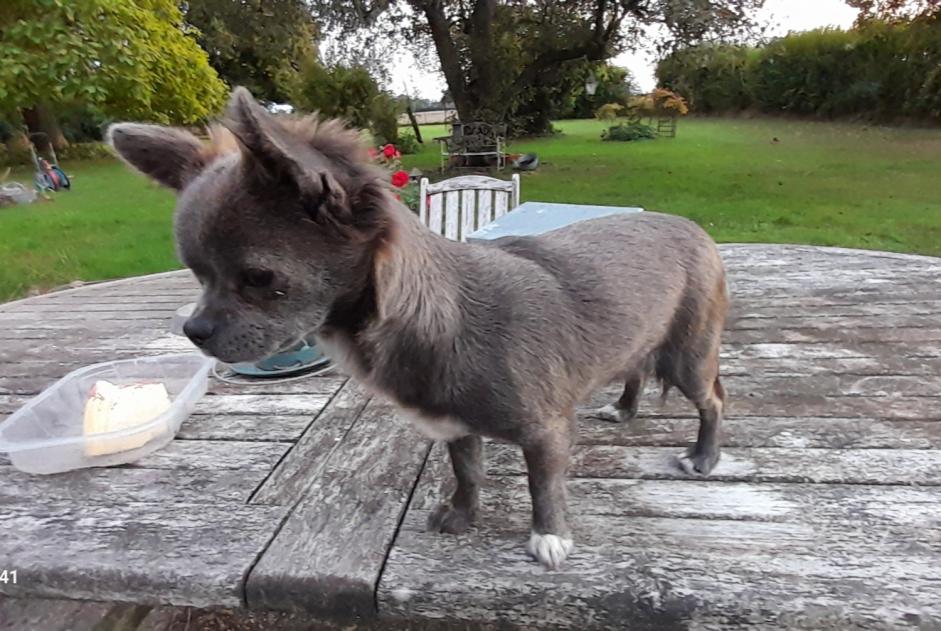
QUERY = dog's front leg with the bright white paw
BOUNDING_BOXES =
[523,429,573,570]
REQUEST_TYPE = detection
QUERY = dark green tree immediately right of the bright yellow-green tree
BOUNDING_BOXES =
[186,0,317,101]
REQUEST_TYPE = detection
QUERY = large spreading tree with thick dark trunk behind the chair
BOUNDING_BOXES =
[311,0,764,132]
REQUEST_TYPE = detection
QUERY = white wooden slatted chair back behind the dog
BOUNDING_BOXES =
[418,174,520,241]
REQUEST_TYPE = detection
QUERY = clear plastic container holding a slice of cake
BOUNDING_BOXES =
[0,353,213,473]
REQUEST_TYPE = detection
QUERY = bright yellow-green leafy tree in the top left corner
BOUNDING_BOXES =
[0,0,226,149]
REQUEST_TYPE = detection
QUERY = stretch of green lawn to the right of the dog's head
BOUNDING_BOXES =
[405,119,941,255]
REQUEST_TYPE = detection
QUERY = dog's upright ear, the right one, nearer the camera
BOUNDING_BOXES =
[224,88,352,224]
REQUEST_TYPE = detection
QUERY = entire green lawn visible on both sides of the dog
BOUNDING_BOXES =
[0,119,941,301]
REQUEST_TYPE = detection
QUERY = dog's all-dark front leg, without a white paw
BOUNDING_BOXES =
[428,436,484,535]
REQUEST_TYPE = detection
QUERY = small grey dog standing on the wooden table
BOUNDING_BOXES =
[109,89,728,568]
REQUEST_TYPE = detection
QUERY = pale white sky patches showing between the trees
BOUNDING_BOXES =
[389,0,856,100]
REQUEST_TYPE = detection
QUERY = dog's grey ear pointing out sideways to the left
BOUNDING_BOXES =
[107,123,205,191]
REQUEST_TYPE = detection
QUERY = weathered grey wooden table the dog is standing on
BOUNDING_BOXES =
[0,245,941,629]
